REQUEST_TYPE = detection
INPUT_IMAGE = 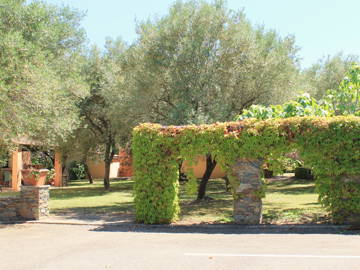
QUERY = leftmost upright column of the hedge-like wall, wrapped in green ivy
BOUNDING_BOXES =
[133,126,179,223]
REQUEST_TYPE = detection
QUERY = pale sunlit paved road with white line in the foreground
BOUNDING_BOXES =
[0,224,360,270]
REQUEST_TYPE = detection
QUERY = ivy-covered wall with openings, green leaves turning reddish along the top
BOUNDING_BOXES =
[132,117,360,223]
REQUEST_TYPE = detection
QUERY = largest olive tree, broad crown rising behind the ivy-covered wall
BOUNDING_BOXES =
[128,1,298,197]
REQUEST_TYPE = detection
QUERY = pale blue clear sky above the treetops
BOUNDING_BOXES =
[44,0,360,68]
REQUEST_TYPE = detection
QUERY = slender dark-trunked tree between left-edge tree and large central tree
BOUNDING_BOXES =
[78,40,137,189]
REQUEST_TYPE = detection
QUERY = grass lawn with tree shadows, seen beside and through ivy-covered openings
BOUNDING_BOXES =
[50,179,327,224]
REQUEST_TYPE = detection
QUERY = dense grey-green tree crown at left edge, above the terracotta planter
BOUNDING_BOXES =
[0,0,86,156]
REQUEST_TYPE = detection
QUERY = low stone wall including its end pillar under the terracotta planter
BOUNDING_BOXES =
[0,186,49,221]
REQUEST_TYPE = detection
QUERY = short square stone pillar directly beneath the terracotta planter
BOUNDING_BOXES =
[19,186,49,220]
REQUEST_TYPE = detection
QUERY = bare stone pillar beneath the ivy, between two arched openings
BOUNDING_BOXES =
[232,159,262,224]
